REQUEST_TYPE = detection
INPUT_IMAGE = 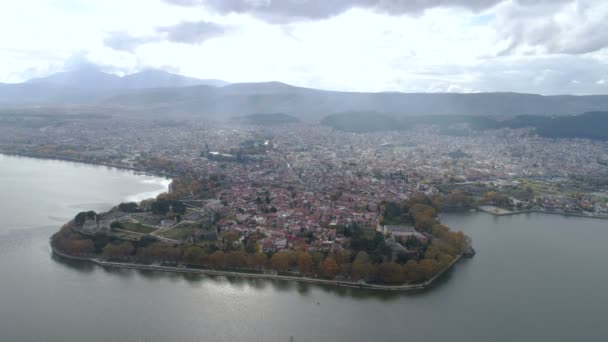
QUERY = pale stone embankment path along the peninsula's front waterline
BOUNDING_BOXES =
[51,246,463,291]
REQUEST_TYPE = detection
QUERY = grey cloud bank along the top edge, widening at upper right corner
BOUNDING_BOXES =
[164,0,608,56]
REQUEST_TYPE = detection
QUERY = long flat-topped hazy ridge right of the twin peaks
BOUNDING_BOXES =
[101,86,608,120]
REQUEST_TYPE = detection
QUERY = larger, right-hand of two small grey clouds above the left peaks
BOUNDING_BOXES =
[157,21,226,44]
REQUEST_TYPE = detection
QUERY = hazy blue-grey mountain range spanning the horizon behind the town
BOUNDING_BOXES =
[0,69,608,120]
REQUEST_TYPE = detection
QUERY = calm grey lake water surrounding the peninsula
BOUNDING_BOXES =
[0,156,608,342]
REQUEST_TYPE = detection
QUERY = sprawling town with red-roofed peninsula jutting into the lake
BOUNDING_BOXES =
[0,113,608,284]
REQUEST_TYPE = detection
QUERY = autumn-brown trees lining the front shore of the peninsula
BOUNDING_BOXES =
[52,223,453,284]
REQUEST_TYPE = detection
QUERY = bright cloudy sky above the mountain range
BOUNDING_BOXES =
[0,0,608,94]
